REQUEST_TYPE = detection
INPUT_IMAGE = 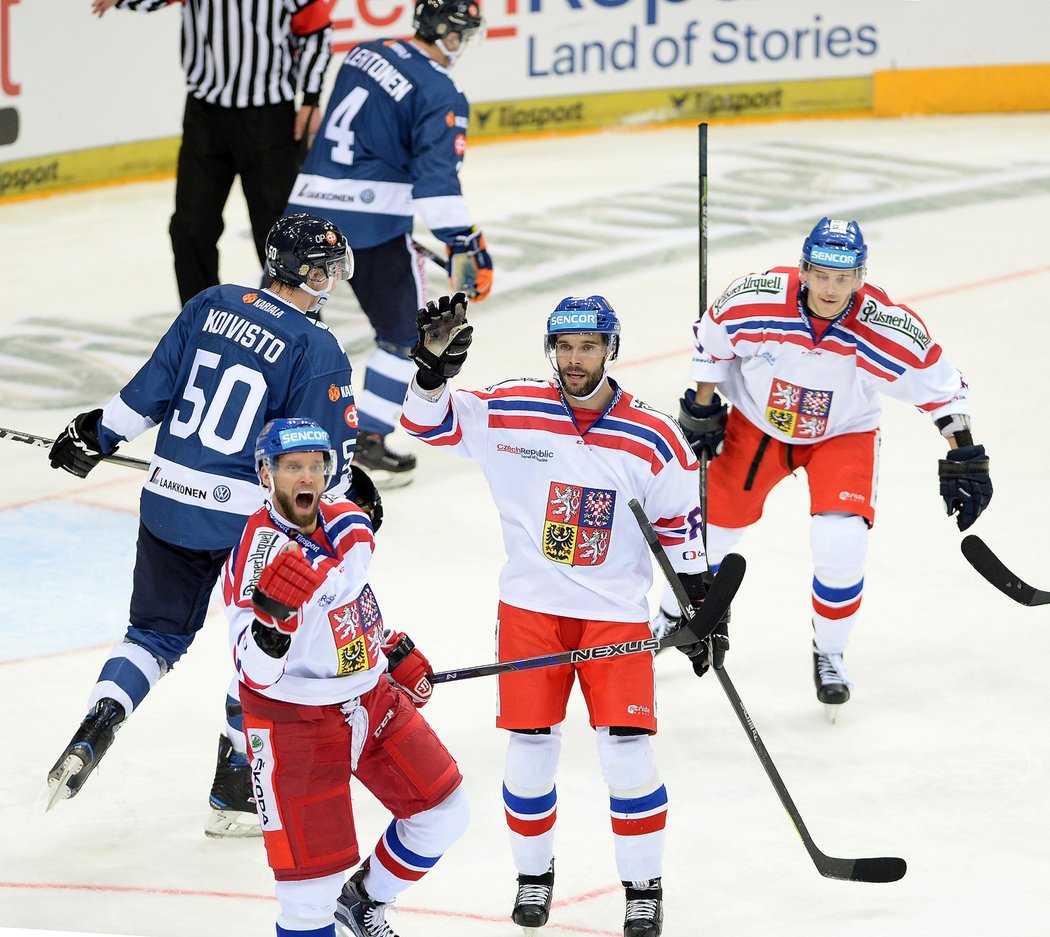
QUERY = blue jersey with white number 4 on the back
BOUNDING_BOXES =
[286,39,473,250]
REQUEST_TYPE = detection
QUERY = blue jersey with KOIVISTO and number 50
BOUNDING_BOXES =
[99,286,357,549]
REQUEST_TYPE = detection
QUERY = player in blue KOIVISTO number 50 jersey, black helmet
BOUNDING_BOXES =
[47,214,375,836]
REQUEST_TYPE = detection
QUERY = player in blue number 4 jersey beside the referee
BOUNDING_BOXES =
[287,0,492,485]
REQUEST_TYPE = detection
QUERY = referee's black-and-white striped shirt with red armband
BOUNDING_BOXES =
[117,0,332,107]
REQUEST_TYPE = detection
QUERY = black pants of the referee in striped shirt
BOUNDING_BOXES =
[168,95,299,305]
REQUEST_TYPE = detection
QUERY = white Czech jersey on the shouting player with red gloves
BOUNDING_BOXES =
[223,499,386,706]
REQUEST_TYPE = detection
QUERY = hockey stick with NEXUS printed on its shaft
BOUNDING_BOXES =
[431,554,744,684]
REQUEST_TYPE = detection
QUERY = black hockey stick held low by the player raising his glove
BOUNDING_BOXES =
[629,500,908,881]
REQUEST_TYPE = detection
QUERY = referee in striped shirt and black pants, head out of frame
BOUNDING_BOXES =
[91,0,332,305]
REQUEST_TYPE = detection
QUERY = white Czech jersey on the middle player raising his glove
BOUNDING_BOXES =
[401,380,708,622]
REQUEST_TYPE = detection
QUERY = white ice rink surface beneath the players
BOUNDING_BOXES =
[0,114,1050,937]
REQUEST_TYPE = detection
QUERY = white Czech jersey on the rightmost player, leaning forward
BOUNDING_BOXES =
[690,267,970,443]
